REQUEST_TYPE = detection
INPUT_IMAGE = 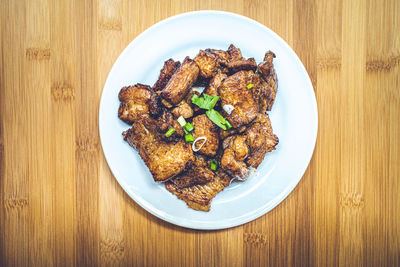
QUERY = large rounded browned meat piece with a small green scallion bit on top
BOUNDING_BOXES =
[218,71,258,128]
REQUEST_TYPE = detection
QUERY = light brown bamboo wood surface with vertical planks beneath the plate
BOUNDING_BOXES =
[0,0,400,266]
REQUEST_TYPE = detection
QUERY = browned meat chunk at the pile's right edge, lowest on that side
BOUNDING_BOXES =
[246,114,279,168]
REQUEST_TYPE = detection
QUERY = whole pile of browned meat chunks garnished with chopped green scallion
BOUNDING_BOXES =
[118,45,279,211]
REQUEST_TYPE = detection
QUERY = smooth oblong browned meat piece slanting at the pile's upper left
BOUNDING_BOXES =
[160,57,199,105]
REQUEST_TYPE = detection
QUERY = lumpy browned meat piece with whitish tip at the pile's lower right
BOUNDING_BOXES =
[221,136,249,179]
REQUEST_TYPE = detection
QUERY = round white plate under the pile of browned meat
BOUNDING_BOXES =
[99,11,318,229]
